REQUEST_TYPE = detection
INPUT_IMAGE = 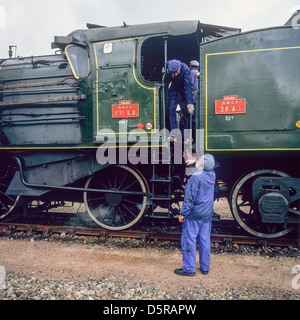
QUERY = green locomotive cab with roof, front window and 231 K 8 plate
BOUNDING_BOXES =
[53,21,240,144]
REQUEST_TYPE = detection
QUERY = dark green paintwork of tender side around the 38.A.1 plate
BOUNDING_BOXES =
[201,27,300,150]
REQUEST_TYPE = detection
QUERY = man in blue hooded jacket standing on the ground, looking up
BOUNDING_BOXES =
[174,153,216,276]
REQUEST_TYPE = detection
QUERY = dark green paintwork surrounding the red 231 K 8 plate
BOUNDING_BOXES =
[94,39,157,138]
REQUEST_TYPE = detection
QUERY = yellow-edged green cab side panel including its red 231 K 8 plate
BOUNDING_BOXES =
[94,39,158,140]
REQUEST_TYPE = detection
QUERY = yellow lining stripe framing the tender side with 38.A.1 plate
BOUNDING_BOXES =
[205,46,300,151]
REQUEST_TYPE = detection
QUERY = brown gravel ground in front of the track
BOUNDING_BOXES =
[0,235,300,301]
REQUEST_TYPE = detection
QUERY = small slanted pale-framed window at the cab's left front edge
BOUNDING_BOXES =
[66,45,90,79]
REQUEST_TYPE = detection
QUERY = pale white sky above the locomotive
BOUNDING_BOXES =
[0,0,300,58]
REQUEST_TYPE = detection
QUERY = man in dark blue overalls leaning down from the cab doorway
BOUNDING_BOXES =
[167,60,194,142]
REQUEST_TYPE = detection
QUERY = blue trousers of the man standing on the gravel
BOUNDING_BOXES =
[181,219,211,272]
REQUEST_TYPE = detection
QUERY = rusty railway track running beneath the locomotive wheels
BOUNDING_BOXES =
[0,223,300,249]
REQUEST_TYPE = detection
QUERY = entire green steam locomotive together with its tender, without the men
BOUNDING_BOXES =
[0,21,300,238]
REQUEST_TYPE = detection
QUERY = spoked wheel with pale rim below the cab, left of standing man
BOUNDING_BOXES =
[84,165,149,230]
